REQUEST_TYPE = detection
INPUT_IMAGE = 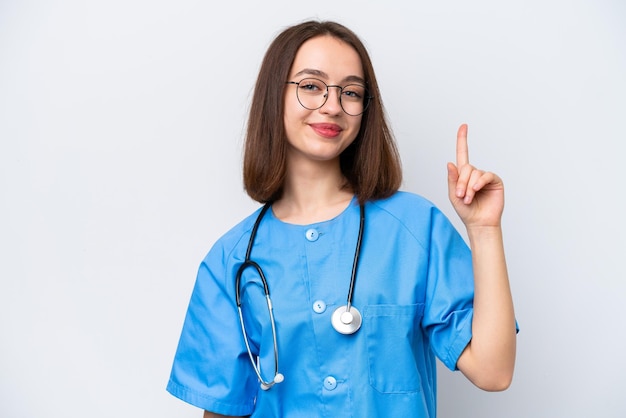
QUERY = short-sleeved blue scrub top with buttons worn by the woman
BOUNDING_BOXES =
[167,192,474,418]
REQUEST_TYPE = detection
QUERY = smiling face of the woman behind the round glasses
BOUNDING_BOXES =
[284,36,365,162]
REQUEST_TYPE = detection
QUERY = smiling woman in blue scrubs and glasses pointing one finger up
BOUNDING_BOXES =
[168,22,516,418]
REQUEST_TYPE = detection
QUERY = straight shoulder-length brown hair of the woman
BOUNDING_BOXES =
[243,21,402,203]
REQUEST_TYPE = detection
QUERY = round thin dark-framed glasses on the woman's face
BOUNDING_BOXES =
[286,78,372,116]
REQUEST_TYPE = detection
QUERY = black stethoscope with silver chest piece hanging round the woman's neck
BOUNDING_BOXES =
[235,203,365,390]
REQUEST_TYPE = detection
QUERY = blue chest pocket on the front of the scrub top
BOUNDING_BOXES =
[364,303,424,393]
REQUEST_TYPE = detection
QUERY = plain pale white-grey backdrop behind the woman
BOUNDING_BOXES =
[0,0,626,418]
